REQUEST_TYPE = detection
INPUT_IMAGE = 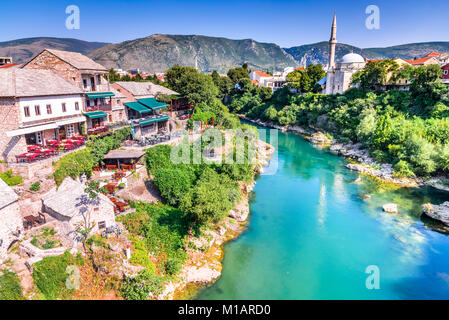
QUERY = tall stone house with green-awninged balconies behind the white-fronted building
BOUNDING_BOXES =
[23,49,126,127]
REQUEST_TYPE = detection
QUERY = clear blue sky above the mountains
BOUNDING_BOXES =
[0,0,449,48]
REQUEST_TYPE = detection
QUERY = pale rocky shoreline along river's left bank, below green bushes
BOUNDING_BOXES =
[155,140,274,300]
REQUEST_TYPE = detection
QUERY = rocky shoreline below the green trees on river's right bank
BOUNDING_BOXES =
[239,115,449,192]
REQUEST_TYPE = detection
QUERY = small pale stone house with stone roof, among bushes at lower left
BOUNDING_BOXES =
[42,178,115,247]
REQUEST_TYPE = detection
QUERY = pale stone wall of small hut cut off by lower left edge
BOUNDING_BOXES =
[0,201,23,262]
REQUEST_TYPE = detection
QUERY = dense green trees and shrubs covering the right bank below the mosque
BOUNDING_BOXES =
[220,61,449,177]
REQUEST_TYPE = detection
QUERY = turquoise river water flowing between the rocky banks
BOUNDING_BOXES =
[196,126,449,299]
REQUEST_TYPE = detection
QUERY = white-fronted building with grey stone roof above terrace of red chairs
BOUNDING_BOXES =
[0,69,85,162]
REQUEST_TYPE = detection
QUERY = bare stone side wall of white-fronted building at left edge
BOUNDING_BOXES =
[0,98,26,162]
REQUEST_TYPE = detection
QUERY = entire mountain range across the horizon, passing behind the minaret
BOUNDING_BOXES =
[0,33,449,73]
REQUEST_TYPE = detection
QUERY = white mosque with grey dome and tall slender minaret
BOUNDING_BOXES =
[325,15,366,94]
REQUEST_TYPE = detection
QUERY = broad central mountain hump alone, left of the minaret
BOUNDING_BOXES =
[88,34,298,72]
